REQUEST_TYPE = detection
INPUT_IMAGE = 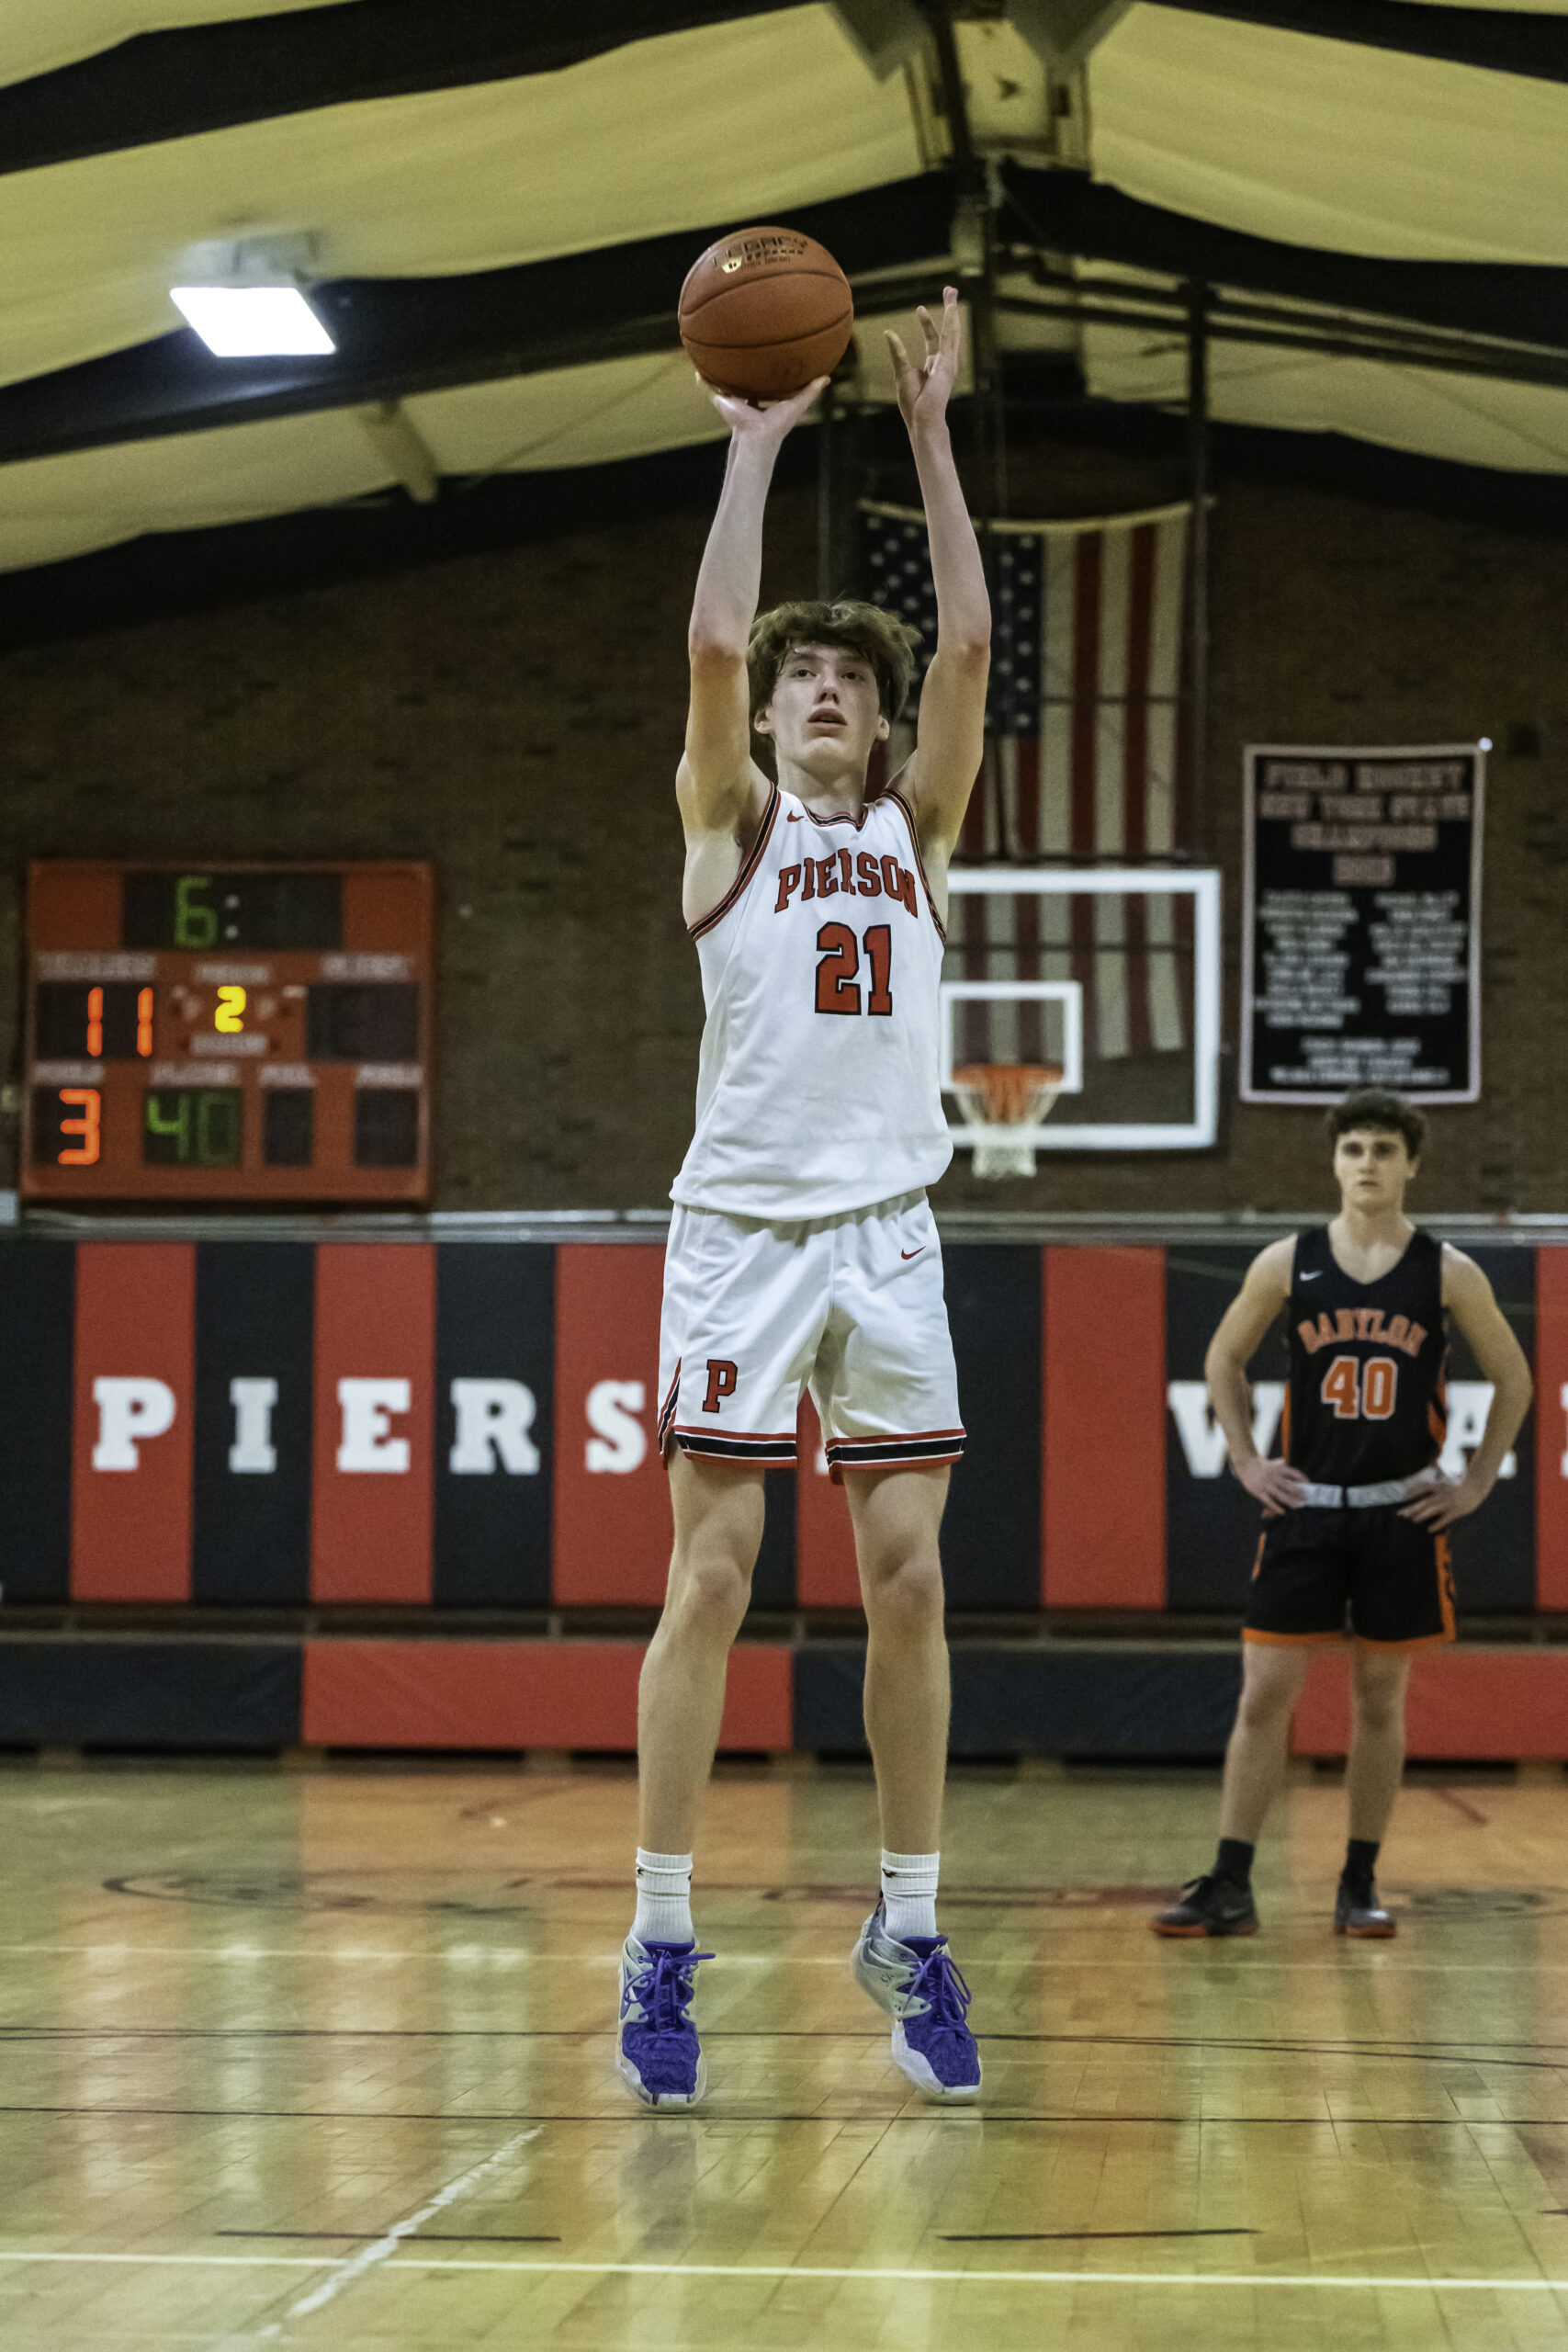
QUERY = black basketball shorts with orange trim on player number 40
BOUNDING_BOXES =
[1241,1505,1453,1649]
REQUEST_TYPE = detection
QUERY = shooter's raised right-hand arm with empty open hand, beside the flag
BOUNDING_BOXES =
[888,287,992,865]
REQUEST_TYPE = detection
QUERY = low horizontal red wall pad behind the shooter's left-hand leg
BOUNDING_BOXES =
[301,1642,795,1750]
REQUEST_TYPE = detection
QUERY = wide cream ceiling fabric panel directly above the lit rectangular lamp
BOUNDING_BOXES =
[0,7,919,381]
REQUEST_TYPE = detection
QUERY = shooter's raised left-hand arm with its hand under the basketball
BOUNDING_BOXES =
[674,381,823,865]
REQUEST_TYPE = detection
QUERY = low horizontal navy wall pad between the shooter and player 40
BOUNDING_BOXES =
[795,1642,1241,1757]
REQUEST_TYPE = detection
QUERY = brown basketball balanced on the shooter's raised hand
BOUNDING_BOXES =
[680,228,856,400]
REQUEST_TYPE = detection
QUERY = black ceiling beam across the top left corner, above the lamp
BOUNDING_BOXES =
[0,0,795,172]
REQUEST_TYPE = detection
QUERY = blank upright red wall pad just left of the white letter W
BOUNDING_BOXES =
[1042,1249,1166,1609]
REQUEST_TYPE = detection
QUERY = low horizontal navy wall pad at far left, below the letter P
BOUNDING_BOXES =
[0,1634,303,1750]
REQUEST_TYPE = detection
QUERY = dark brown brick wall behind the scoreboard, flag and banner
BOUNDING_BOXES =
[0,454,1568,1209]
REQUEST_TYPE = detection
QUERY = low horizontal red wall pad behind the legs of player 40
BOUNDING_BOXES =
[1291,1649,1568,1761]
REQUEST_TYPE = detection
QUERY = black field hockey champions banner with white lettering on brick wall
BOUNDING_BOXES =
[1241,743,1485,1103]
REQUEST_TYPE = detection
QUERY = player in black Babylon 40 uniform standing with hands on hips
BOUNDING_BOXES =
[1152,1089,1530,1936]
